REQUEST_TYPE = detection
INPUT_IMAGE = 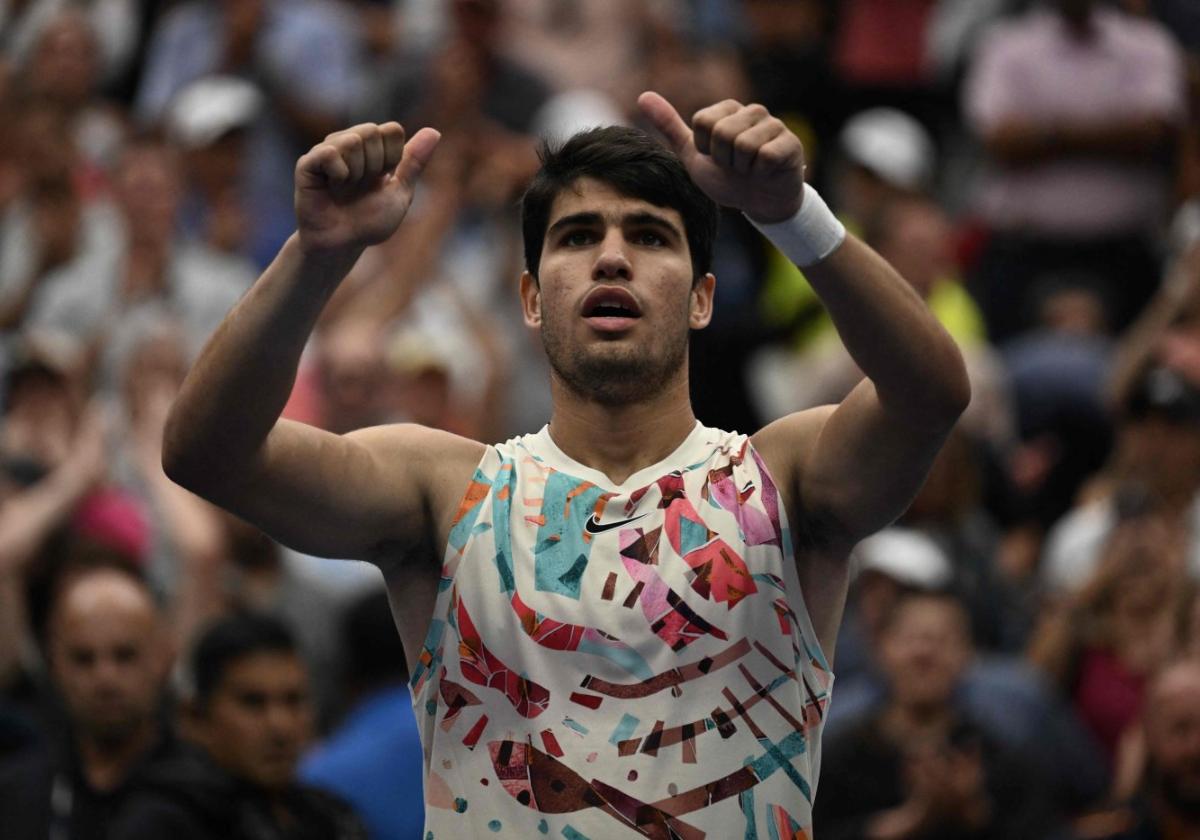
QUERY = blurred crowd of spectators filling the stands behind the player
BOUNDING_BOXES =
[0,0,1200,840]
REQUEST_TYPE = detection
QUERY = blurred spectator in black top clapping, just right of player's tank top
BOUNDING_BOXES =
[814,594,1052,840]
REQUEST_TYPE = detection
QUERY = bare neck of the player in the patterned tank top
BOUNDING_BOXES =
[550,377,696,484]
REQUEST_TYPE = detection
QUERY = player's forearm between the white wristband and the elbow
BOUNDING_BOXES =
[804,236,970,425]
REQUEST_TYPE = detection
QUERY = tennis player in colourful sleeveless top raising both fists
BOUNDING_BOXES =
[164,92,970,838]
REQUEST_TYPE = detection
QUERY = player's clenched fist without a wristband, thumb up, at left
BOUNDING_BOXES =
[295,122,440,253]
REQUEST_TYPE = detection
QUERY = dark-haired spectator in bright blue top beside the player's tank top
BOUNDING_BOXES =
[300,589,425,840]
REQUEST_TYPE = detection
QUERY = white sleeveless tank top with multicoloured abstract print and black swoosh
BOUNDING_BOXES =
[410,422,833,840]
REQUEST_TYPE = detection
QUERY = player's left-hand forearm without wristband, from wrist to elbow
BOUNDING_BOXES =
[163,235,360,494]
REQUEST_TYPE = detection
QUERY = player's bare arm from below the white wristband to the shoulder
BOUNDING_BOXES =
[755,236,970,537]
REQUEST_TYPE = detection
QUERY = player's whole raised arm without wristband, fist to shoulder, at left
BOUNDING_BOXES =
[163,122,482,559]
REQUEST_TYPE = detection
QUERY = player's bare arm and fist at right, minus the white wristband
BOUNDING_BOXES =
[638,94,971,654]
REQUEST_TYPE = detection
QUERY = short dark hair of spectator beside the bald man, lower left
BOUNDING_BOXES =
[190,613,296,709]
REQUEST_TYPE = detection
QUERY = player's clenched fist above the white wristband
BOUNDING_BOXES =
[637,91,804,224]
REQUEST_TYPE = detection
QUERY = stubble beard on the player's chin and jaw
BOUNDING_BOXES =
[541,320,689,406]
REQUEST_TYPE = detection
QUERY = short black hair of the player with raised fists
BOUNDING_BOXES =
[521,126,719,280]
